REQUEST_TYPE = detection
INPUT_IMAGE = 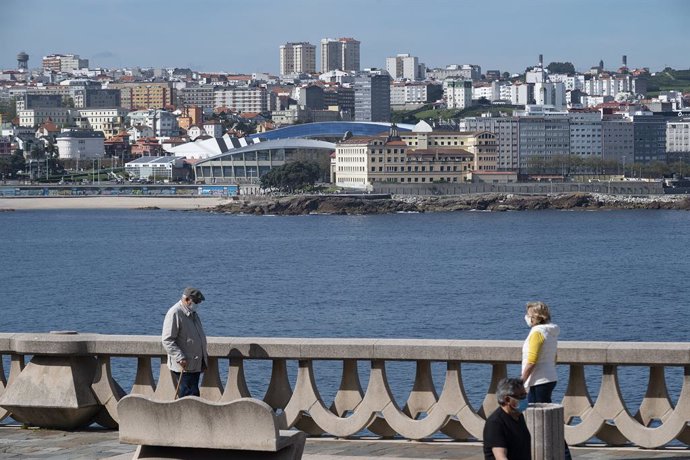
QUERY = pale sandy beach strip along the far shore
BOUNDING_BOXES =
[0,196,230,211]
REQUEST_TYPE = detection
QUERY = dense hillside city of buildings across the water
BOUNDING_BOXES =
[0,38,690,191]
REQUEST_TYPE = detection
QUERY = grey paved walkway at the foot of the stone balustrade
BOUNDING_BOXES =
[0,425,690,460]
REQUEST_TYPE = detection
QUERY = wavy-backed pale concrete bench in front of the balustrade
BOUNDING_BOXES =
[117,395,306,460]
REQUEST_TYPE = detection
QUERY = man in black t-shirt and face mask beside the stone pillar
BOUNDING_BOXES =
[483,378,532,460]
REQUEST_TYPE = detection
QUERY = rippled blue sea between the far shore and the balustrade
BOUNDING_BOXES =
[0,210,690,416]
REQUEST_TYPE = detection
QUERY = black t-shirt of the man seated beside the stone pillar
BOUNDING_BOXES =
[484,407,532,460]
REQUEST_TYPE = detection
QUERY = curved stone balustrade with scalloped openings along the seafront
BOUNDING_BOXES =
[0,333,690,448]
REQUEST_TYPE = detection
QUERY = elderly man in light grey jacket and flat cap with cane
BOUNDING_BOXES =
[161,287,208,398]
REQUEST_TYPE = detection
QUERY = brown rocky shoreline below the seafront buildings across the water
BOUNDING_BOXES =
[206,193,690,216]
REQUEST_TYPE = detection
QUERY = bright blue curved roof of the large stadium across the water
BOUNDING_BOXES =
[249,121,414,140]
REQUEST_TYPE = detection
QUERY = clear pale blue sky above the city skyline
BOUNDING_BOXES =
[0,0,690,74]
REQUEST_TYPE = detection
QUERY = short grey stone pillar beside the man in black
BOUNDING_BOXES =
[525,403,565,460]
